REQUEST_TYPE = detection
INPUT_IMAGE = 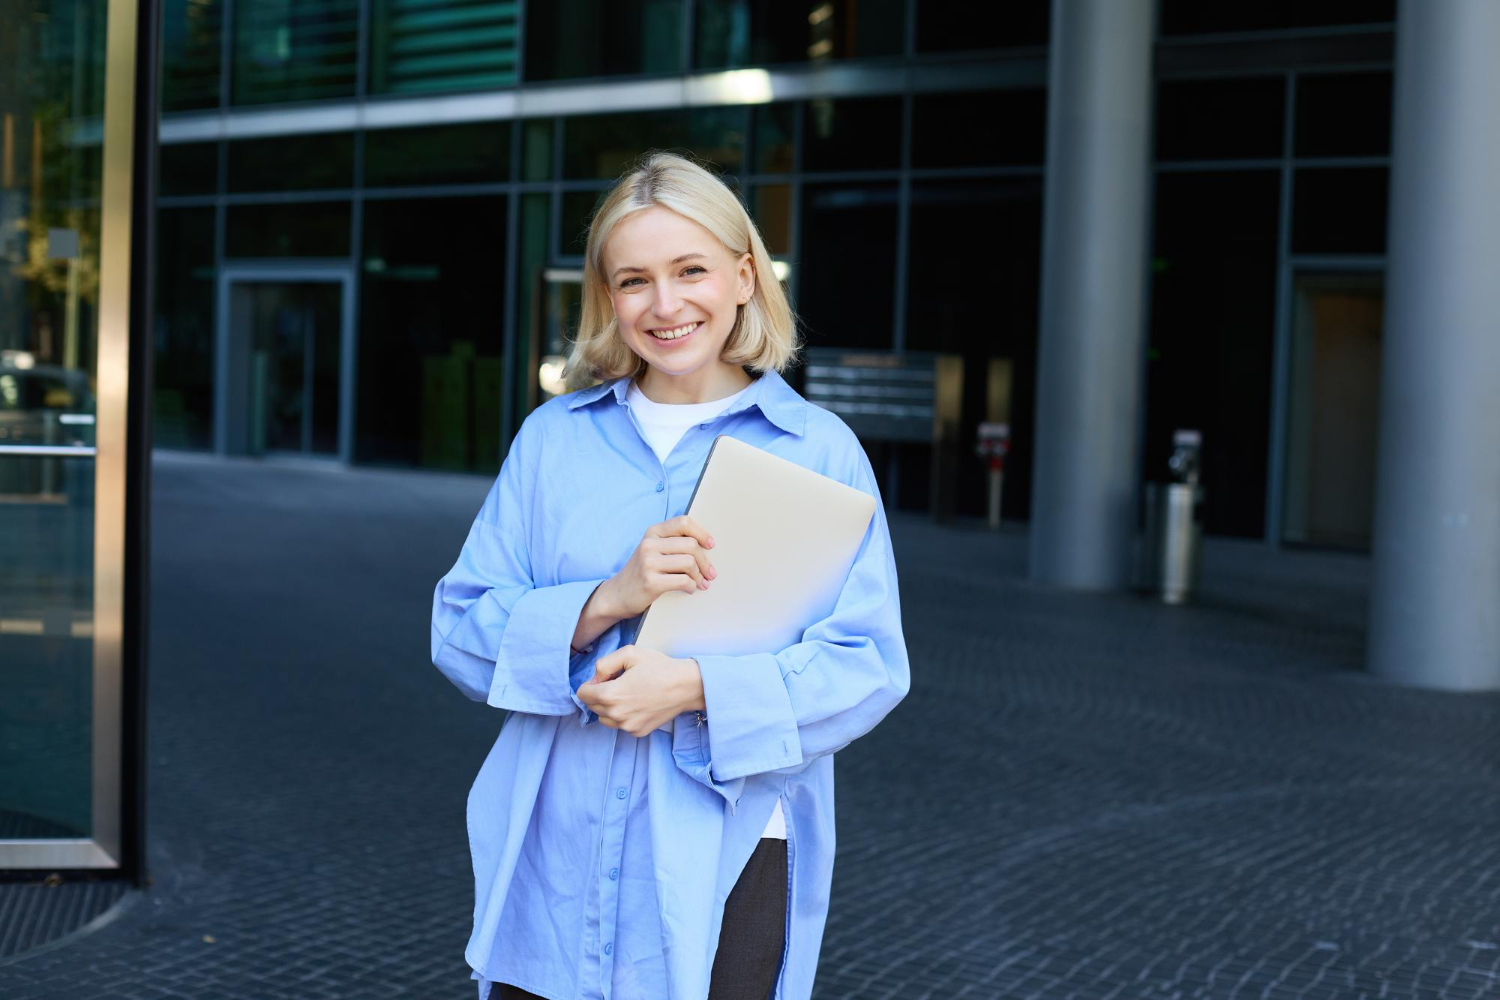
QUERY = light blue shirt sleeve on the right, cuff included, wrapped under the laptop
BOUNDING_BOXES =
[675,445,911,805]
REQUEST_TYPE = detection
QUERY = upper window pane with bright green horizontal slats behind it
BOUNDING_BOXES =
[371,0,519,93]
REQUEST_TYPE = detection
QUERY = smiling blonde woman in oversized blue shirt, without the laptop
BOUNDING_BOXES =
[432,153,909,1000]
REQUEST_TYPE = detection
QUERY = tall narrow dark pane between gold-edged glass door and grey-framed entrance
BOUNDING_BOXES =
[152,208,215,448]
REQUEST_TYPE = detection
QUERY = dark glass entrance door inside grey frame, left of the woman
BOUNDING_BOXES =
[218,268,354,462]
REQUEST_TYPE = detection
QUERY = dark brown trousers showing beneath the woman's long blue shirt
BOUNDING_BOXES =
[495,837,786,1000]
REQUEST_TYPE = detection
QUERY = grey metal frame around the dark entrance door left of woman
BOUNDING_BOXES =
[213,261,357,465]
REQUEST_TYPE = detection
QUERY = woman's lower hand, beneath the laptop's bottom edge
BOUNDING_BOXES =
[578,646,704,736]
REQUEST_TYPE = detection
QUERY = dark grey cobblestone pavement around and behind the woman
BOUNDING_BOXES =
[0,457,1500,1000]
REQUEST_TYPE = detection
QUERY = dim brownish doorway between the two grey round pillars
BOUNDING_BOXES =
[1281,271,1385,549]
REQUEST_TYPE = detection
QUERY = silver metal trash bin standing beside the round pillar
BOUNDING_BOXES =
[1143,430,1203,604]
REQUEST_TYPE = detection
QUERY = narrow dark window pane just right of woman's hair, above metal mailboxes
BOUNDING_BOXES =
[797,184,896,348]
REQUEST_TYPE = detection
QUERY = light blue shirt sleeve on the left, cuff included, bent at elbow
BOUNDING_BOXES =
[432,416,602,715]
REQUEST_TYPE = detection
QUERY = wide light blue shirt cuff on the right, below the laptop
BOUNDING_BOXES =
[693,652,803,781]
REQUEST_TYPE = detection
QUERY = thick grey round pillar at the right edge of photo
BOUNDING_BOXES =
[1368,0,1500,690]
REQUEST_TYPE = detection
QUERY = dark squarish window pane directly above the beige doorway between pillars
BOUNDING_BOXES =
[1292,166,1389,253]
